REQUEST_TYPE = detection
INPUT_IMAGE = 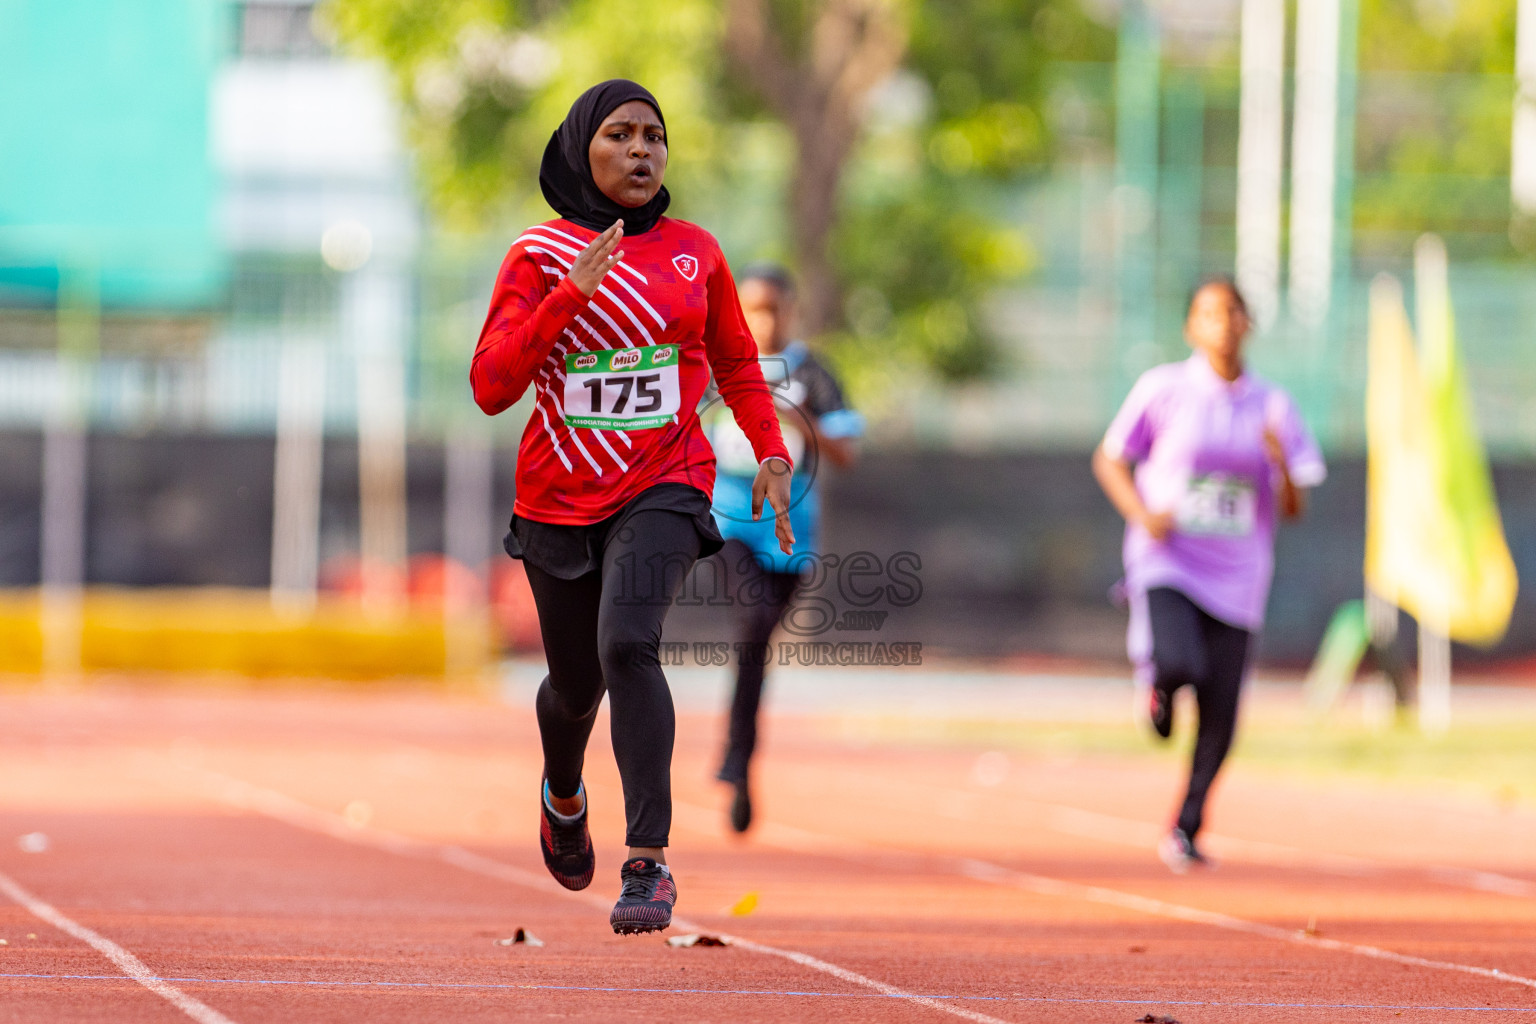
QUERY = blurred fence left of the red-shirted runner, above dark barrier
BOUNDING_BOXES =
[0,253,499,436]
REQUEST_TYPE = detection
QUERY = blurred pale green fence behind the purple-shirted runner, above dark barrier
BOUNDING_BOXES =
[946,66,1536,457]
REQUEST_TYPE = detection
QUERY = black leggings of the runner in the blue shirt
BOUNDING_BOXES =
[717,540,800,783]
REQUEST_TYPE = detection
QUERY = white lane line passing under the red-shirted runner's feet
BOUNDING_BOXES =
[181,766,1009,1024]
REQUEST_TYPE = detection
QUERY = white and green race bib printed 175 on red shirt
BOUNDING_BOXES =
[565,345,682,430]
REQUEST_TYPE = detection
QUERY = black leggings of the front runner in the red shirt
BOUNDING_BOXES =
[527,508,699,846]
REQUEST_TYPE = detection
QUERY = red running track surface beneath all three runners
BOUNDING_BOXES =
[0,688,1536,1024]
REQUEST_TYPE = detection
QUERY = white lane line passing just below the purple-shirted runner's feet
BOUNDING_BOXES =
[673,800,1536,989]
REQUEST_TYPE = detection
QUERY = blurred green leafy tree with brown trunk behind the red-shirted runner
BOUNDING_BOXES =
[323,0,1114,387]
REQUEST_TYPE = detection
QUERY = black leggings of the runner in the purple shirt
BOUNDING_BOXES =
[1147,586,1252,838]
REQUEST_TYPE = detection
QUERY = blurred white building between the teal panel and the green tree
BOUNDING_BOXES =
[209,0,421,430]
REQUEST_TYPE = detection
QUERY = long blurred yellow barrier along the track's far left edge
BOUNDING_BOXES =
[0,586,498,680]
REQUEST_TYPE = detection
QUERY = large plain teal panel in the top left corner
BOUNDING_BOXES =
[0,0,227,310]
